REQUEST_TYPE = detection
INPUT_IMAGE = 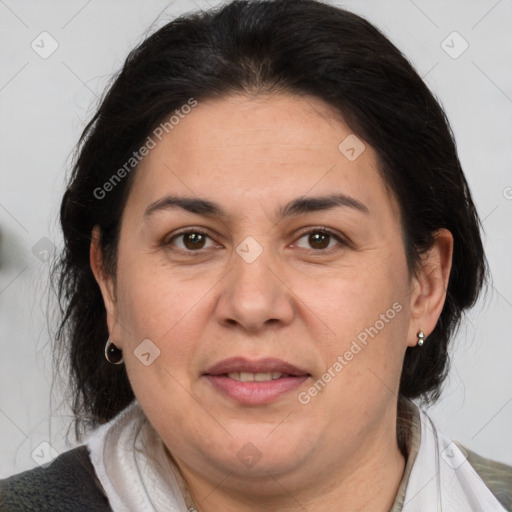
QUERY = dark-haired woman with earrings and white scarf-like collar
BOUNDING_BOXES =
[0,0,512,512]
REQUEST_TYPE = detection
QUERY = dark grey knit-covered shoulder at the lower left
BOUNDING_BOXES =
[0,446,112,512]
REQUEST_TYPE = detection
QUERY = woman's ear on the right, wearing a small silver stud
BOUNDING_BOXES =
[407,228,453,347]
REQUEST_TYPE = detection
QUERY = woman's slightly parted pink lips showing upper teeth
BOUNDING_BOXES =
[203,357,311,405]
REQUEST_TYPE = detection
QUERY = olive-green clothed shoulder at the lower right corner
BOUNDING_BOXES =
[456,443,512,511]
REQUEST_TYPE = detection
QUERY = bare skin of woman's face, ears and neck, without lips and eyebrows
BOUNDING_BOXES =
[91,94,453,512]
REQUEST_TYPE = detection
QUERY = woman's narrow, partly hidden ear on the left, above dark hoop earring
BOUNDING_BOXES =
[89,225,120,342]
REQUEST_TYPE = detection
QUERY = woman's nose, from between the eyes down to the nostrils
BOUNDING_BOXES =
[216,250,295,332]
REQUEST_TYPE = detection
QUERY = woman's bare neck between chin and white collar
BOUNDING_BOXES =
[179,409,405,512]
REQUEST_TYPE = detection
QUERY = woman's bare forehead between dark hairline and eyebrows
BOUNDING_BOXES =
[124,95,392,221]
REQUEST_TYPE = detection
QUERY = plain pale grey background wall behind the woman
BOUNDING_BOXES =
[0,0,512,478]
